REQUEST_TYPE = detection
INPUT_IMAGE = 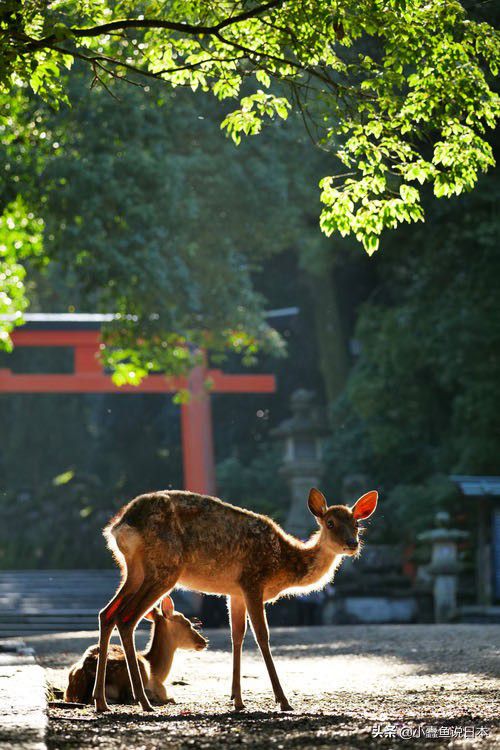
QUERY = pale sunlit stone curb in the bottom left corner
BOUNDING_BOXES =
[0,640,47,750]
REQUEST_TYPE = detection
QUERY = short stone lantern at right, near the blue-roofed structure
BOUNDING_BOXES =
[418,511,468,622]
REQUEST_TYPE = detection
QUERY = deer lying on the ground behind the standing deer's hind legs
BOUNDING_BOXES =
[64,596,207,704]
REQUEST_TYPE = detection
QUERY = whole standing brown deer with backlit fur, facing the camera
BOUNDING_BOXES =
[93,488,378,711]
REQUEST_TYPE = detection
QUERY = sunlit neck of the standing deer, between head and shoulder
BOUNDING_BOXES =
[286,531,342,591]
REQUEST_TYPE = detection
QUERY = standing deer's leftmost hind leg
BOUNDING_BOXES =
[92,563,144,712]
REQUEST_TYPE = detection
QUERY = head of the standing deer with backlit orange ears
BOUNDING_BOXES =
[308,487,378,555]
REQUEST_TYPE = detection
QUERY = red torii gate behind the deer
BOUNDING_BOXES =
[0,313,276,494]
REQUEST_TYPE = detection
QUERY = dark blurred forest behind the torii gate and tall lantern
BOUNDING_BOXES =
[0,50,500,568]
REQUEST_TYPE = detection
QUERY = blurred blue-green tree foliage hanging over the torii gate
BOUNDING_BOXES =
[3,69,289,372]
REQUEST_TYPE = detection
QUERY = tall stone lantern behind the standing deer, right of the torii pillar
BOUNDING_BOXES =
[271,389,328,537]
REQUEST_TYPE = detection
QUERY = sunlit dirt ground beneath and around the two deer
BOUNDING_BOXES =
[27,625,500,750]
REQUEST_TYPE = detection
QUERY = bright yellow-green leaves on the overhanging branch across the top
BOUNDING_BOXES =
[0,0,499,253]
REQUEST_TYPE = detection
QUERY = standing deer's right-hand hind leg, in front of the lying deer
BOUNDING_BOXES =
[117,578,176,711]
